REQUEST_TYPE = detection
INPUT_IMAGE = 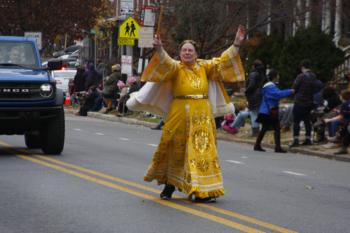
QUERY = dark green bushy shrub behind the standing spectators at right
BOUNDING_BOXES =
[241,27,344,88]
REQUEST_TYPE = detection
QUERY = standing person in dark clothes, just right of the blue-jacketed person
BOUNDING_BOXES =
[290,59,322,147]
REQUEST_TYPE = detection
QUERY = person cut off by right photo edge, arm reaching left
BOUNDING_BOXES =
[324,90,350,154]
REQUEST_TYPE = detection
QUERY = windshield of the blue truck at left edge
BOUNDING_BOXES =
[0,41,39,68]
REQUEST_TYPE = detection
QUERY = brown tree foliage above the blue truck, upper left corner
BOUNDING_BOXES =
[0,0,110,42]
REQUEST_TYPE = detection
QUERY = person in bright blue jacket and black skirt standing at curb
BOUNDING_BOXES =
[254,69,294,153]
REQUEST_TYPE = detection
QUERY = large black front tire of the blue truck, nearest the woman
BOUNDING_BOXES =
[40,107,65,155]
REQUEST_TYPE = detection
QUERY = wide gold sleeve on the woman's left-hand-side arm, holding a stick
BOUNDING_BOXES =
[141,48,179,82]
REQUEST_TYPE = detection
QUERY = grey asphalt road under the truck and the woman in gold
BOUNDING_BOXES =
[0,115,350,233]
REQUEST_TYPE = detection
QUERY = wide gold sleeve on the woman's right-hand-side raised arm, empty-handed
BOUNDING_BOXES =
[204,45,245,82]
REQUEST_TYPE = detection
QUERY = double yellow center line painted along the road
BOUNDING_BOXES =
[0,141,296,233]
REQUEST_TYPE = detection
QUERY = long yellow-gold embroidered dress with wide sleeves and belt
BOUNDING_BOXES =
[141,46,244,198]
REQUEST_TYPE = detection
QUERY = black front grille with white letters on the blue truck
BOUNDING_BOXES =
[0,83,50,100]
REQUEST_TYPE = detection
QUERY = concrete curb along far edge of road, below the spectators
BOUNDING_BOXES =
[65,108,350,162]
